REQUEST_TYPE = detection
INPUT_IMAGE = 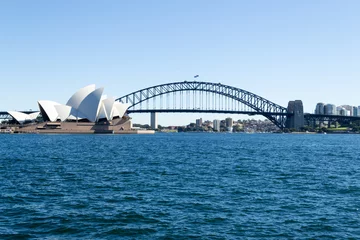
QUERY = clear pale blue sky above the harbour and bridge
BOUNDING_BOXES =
[0,0,360,125]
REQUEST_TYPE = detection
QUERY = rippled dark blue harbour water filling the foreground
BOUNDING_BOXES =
[0,133,360,239]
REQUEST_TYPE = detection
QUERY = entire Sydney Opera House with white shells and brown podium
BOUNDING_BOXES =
[3,84,145,133]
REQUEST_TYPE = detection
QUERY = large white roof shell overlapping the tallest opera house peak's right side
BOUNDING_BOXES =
[77,88,104,122]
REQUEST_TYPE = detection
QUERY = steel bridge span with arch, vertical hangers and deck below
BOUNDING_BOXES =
[116,81,291,129]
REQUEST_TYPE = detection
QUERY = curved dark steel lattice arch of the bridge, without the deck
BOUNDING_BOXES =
[116,81,288,129]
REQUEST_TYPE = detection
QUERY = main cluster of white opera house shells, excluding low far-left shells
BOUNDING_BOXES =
[38,84,129,122]
